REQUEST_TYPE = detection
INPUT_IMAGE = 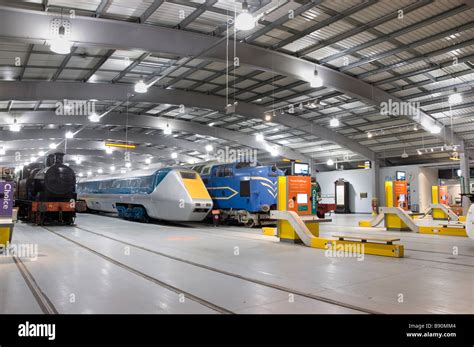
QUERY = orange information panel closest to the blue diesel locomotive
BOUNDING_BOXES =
[287,176,311,215]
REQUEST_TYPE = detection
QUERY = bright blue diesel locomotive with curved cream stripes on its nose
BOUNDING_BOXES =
[192,162,284,227]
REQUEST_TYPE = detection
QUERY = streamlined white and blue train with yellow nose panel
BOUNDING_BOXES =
[77,167,213,222]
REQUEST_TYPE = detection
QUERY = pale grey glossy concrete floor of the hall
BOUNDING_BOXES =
[0,214,474,314]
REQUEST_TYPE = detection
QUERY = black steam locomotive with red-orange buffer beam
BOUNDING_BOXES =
[15,152,77,225]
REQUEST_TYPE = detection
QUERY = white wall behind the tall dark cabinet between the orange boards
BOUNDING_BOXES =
[316,170,372,213]
